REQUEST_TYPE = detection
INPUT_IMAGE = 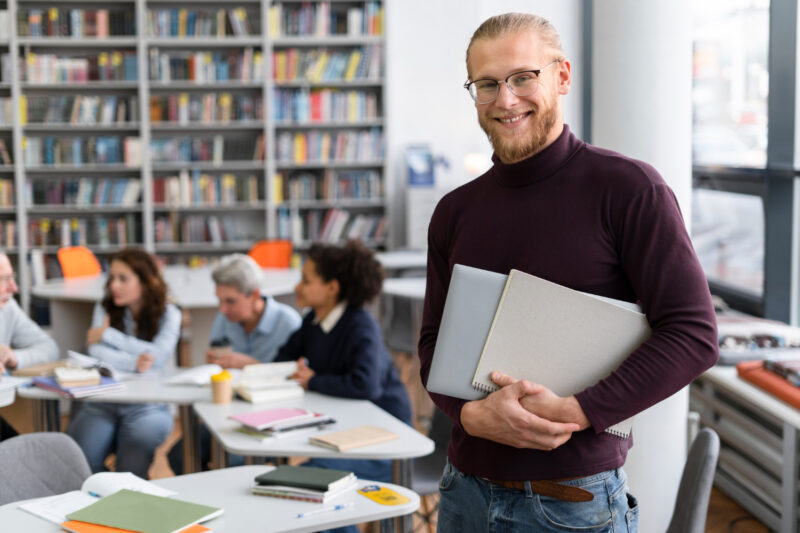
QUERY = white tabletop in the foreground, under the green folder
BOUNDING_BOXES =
[0,466,419,533]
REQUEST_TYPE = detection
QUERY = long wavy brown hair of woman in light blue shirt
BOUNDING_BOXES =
[103,248,167,341]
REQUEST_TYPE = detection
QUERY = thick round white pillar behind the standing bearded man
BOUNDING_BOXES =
[591,0,692,533]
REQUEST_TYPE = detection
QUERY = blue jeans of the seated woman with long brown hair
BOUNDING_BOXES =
[67,402,173,479]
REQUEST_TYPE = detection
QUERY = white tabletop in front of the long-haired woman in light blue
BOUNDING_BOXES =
[17,371,216,405]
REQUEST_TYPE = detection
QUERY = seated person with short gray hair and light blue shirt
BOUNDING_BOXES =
[206,254,302,368]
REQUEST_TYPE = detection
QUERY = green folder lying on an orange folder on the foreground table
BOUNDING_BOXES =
[67,489,223,533]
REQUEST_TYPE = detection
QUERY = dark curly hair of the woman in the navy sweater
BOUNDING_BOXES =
[308,239,384,307]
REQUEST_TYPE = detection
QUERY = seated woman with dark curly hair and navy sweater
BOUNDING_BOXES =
[276,240,411,490]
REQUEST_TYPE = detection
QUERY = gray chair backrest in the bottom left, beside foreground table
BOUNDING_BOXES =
[0,433,92,505]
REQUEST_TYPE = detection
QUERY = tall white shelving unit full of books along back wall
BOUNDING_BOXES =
[0,0,391,308]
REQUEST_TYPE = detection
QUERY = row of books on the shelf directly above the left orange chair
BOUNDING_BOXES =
[28,213,142,246]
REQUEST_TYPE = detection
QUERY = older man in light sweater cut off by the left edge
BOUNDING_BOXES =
[0,250,58,439]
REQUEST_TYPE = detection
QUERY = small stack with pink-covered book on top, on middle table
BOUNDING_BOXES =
[228,407,335,439]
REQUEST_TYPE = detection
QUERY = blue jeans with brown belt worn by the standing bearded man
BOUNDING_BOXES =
[437,461,639,533]
